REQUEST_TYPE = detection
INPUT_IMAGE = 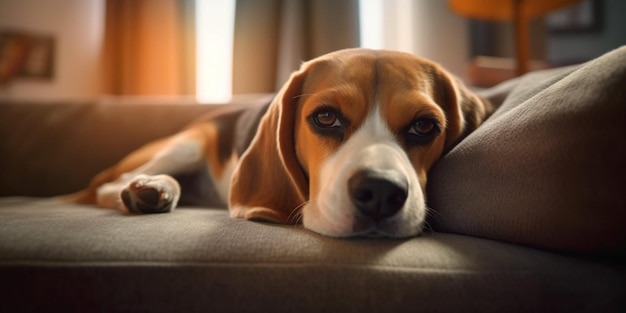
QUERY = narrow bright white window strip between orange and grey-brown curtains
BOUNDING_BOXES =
[196,0,236,103]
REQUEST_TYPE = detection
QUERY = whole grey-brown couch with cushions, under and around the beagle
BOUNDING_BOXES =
[0,48,626,312]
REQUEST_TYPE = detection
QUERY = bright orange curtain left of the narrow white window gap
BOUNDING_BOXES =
[102,0,195,95]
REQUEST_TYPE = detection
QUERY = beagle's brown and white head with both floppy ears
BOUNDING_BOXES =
[230,49,492,237]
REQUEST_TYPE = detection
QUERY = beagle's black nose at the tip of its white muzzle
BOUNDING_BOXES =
[348,170,408,221]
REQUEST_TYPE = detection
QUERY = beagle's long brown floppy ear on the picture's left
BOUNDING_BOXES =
[229,65,308,223]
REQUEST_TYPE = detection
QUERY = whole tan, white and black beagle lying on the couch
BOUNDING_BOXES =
[70,49,494,238]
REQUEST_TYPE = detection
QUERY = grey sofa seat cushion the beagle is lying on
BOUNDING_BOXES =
[0,198,626,312]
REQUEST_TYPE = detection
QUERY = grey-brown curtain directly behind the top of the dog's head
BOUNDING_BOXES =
[233,0,359,94]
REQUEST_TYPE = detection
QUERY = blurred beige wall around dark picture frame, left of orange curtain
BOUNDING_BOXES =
[0,0,105,99]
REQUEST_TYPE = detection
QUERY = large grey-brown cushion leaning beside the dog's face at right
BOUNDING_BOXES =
[428,47,626,252]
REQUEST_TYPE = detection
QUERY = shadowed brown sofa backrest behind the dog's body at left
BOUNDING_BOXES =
[0,102,213,197]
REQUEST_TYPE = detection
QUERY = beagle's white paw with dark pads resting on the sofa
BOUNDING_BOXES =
[120,175,180,214]
